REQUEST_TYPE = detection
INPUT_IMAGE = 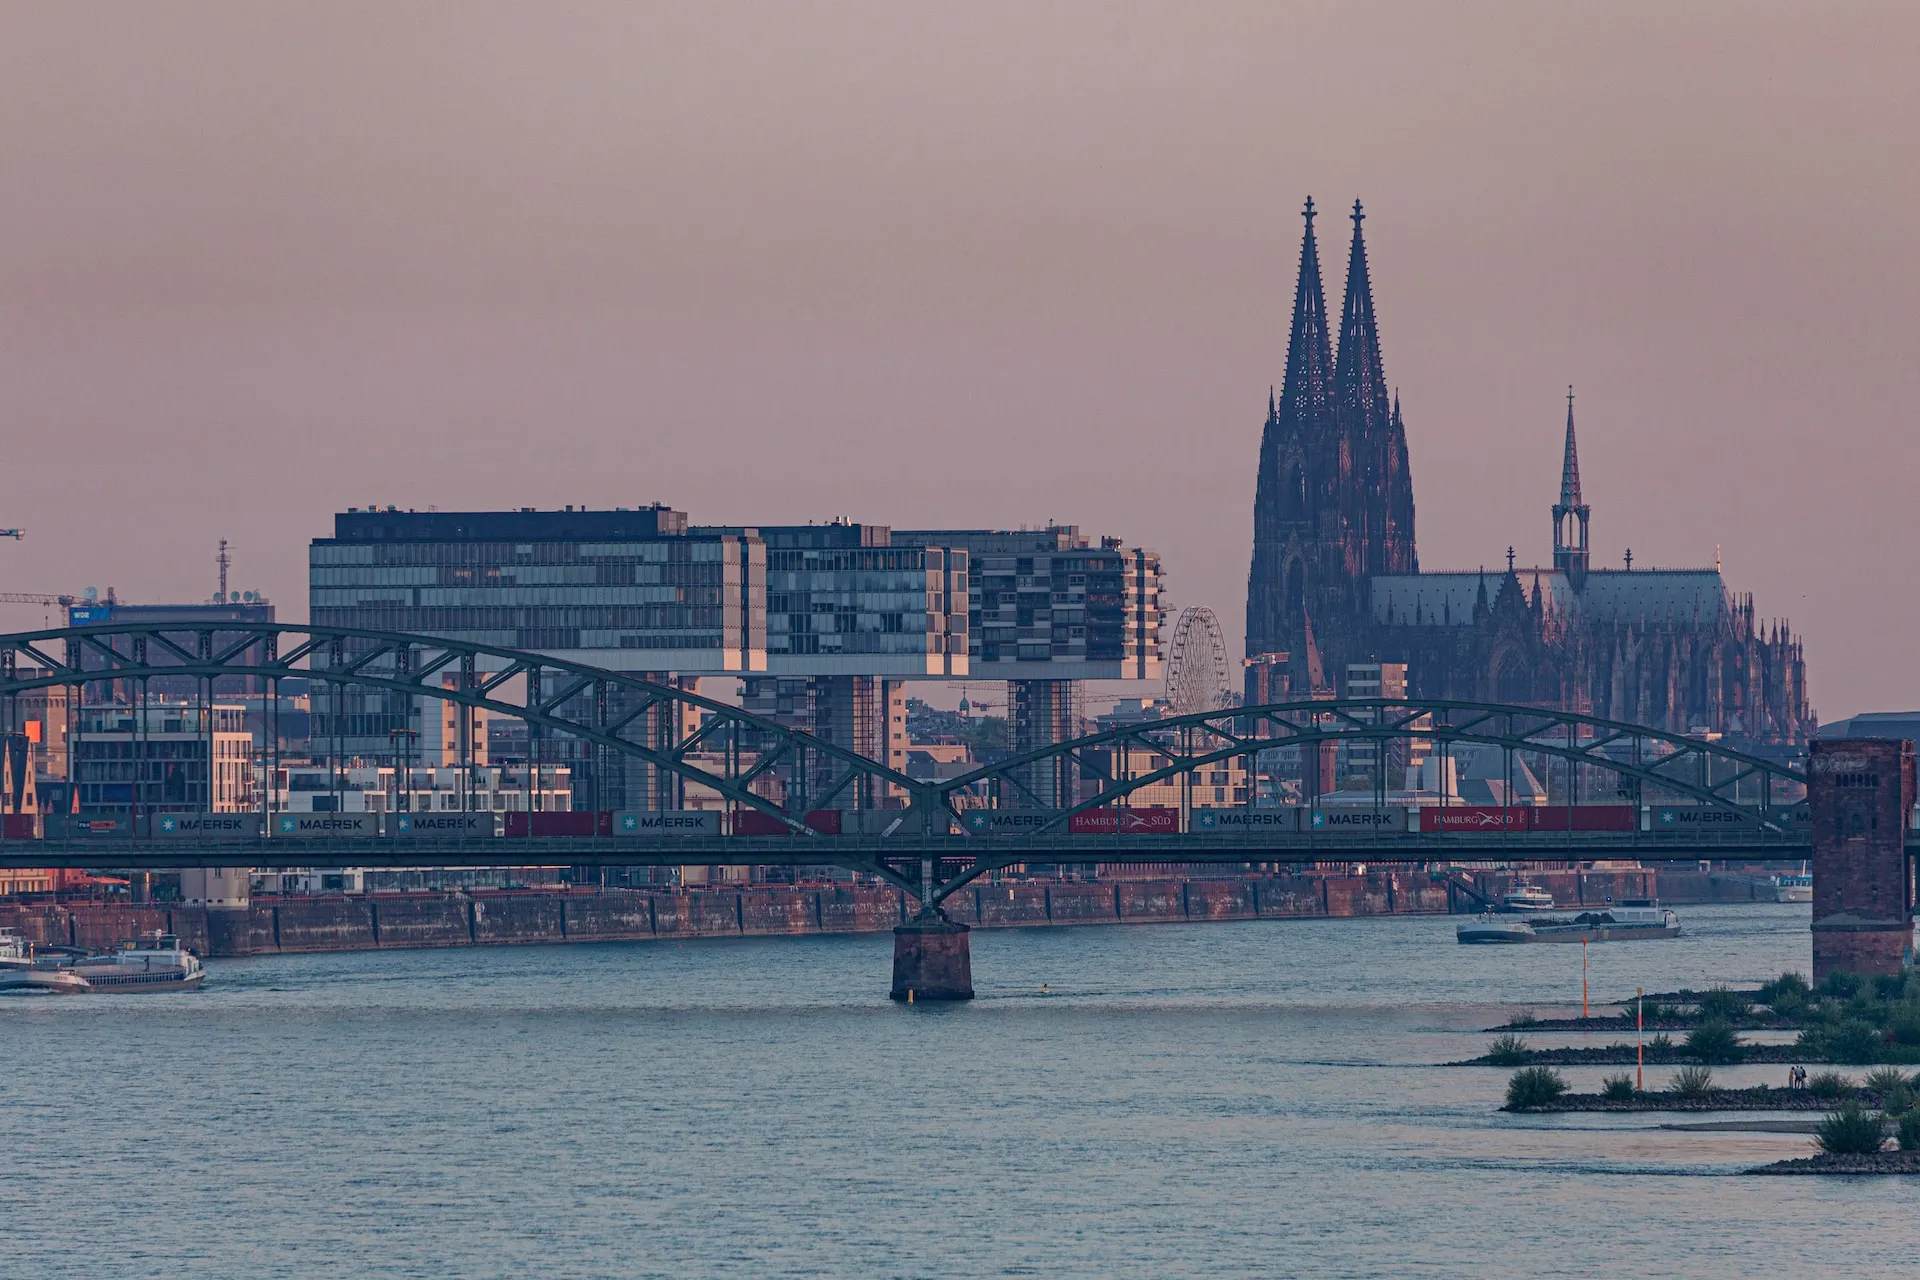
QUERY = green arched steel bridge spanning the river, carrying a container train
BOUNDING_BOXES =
[0,622,1807,910]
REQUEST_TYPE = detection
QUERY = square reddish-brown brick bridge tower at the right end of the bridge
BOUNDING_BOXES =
[1807,739,1914,983]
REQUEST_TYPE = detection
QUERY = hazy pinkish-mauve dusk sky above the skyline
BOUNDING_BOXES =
[0,0,1920,720]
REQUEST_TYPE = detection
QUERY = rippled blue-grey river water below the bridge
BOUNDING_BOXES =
[0,906,1920,1276]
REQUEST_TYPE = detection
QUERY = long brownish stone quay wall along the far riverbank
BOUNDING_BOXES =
[0,869,1720,956]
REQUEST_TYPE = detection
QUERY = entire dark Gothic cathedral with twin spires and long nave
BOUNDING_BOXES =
[1246,200,1814,747]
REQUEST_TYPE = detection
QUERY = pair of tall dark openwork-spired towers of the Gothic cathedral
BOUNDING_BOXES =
[1246,198,1419,675]
